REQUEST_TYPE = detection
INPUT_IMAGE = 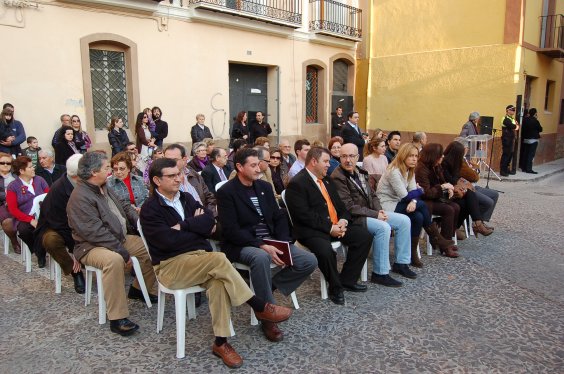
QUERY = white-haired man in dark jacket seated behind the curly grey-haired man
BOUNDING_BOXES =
[33,154,84,294]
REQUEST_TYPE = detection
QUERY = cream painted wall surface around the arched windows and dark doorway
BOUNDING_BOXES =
[0,2,354,147]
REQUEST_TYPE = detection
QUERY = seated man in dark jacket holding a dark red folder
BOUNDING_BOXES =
[217,149,317,342]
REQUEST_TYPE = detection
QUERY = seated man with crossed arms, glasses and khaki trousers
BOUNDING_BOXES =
[140,158,292,368]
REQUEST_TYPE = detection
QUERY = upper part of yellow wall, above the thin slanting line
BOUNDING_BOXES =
[372,0,505,57]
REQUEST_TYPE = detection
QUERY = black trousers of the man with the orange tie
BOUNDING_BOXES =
[299,225,372,293]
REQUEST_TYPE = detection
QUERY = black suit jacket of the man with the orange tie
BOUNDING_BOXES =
[286,168,352,240]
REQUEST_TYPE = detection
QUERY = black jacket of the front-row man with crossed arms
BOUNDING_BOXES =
[139,192,215,265]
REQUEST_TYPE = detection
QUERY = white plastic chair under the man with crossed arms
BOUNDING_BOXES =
[137,221,235,358]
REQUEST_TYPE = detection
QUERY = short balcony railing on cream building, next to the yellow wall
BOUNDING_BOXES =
[309,0,362,40]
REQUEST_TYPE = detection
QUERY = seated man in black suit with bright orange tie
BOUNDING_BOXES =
[286,147,372,305]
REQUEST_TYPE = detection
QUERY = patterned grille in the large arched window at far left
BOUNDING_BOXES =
[90,49,128,130]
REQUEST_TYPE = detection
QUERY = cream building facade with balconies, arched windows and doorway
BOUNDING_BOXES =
[0,0,362,150]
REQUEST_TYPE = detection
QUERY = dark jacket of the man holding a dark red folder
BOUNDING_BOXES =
[217,178,290,261]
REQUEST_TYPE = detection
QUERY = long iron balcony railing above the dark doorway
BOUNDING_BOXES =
[188,0,302,28]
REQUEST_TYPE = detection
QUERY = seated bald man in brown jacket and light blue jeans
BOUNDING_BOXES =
[331,143,417,287]
